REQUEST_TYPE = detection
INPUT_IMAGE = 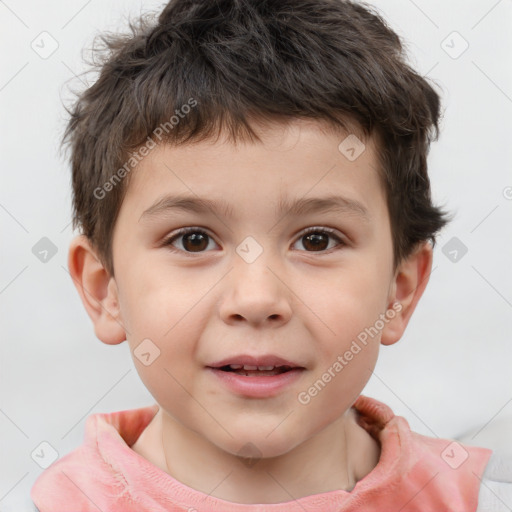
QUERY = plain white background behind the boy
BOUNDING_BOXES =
[0,0,512,511]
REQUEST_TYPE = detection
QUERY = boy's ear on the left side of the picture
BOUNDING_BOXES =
[68,235,126,345]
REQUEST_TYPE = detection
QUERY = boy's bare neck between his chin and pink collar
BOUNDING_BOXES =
[132,408,380,504]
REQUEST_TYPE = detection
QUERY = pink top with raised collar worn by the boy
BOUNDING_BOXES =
[30,395,492,512]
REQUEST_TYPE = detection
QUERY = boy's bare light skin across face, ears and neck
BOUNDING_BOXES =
[68,120,432,504]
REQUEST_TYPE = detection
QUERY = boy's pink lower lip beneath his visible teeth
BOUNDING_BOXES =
[208,367,304,398]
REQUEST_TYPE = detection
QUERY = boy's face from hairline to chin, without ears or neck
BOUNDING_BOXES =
[82,122,424,456]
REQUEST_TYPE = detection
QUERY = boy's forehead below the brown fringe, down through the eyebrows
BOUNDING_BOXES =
[118,121,383,226]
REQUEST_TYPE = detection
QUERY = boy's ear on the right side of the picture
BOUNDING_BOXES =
[381,241,432,345]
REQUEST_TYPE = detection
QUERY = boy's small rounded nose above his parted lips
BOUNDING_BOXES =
[219,254,293,327]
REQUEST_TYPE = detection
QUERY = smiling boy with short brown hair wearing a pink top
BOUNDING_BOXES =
[31,0,506,512]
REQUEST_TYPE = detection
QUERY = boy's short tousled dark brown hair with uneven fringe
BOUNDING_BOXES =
[63,0,450,276]
